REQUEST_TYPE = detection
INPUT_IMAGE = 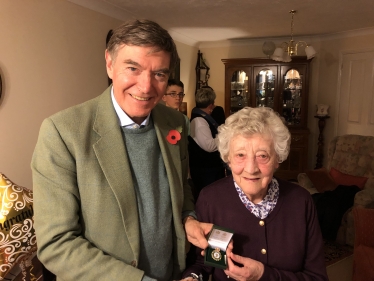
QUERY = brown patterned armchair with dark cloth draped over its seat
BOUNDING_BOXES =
[297,135,374,246]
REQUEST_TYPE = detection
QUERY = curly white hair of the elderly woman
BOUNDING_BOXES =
[217,107,291,163]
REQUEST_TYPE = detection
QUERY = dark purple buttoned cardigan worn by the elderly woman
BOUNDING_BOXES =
[183,176,328,281]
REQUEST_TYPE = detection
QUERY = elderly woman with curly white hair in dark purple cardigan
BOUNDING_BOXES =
[183,107,328,281]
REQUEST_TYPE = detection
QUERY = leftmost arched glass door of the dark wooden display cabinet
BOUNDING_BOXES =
[230,69,249,114]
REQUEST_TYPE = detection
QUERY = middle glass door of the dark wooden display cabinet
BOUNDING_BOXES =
[252,66,277,109]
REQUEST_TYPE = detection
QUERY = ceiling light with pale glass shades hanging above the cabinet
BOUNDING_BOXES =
[271,10,317,62]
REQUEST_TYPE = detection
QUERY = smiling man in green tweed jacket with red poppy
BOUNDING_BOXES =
[31,20,211,281]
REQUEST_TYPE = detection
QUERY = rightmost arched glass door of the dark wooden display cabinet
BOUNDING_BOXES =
[282,69,303,126]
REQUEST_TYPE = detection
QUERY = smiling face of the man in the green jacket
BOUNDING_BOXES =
[105,45,170,124]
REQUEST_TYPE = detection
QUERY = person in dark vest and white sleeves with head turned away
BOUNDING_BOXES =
[188,87,225,198]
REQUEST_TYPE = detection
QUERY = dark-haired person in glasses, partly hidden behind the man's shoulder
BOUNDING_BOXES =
[162,79,190,135]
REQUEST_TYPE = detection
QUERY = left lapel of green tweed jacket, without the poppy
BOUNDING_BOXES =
[93,87,139,258]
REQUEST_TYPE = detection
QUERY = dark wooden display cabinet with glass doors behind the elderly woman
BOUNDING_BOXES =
[222,57,310,180]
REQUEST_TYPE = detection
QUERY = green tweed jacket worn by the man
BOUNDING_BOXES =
[31,87,194,281]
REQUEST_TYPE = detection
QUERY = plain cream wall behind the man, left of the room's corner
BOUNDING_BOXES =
[0,0,197,188]
